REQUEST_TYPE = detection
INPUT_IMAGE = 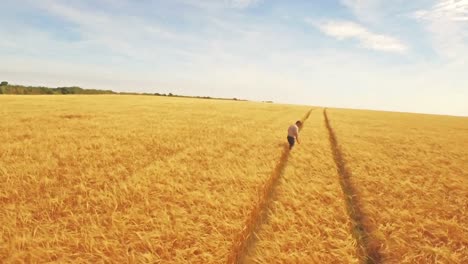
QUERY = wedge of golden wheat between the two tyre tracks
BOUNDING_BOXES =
[245,111,358,263]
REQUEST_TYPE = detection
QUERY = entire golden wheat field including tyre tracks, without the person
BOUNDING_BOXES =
[0,95,468,263]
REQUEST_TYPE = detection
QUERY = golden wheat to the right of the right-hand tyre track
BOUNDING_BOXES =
[329,110,468,263]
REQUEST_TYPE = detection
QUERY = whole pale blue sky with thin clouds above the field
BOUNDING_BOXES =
[0,0,468,116]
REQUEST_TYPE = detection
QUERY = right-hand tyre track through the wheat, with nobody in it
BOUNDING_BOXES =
[323,109,382,264]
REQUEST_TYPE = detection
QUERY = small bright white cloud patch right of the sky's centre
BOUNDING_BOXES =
[309,20,408,53]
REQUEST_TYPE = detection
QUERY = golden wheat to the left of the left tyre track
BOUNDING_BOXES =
[0,96,308,263]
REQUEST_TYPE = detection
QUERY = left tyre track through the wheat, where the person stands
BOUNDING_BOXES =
[227,109,313,264]
